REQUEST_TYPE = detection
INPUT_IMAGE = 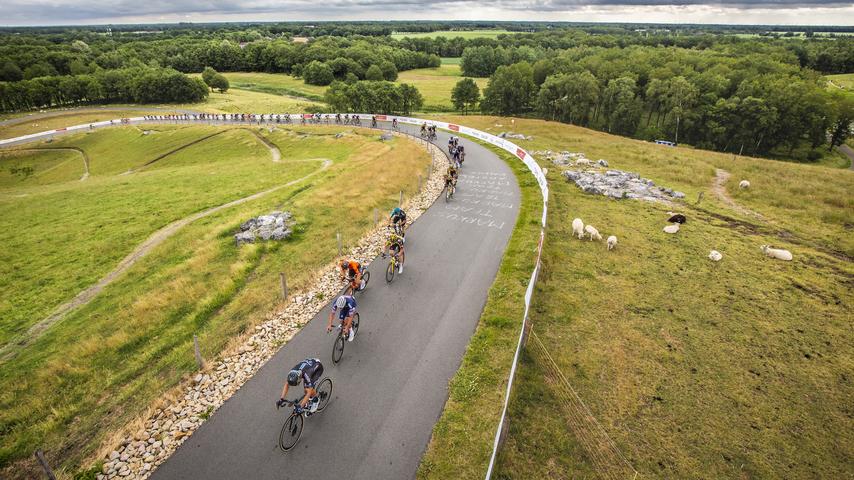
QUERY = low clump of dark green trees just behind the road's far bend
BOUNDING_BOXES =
[324,80,424,115]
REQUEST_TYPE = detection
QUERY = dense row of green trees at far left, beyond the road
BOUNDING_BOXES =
[0,68,208,111]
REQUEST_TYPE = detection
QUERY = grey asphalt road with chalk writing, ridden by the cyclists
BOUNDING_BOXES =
[146,122,520,480]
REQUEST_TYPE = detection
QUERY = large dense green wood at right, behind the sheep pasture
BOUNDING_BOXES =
[464,46,852,159]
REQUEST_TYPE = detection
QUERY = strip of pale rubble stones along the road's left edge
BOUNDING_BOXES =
[97,132,448,480]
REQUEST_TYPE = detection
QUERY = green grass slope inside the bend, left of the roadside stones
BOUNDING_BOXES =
[0,126,429,478]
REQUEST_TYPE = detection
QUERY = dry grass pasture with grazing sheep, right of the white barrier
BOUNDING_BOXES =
[434,117,854,478]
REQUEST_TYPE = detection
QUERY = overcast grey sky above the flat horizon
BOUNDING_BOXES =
[0,0,854,25]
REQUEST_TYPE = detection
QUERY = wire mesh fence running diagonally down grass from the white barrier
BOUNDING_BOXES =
[526,329,638,480]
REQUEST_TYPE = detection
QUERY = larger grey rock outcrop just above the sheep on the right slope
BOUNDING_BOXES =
[562,170,685,201]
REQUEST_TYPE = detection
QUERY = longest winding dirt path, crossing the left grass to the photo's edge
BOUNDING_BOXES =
[0,159,332,361]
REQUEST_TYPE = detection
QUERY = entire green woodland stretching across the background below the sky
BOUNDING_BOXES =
[0,22,854,156]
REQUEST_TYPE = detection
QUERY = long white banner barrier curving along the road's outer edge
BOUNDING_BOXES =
[0,113,549,480]
